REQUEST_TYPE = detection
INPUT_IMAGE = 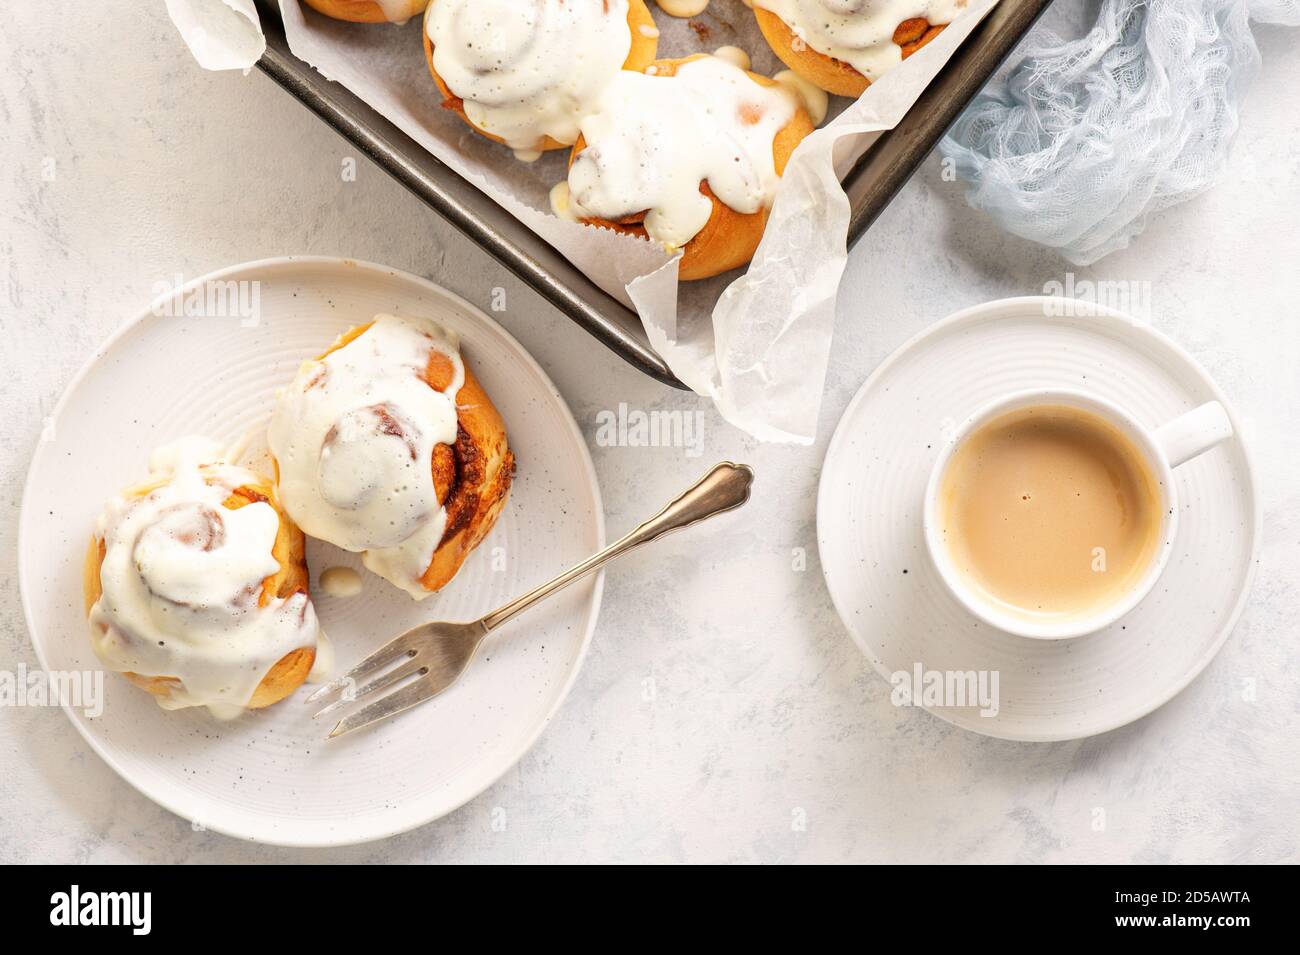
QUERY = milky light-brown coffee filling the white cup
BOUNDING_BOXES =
[937,404,1161,618]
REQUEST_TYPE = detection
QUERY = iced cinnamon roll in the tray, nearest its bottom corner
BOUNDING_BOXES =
[554,55,813,281]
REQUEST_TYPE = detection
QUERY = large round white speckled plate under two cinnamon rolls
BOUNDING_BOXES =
[18,257,605,846]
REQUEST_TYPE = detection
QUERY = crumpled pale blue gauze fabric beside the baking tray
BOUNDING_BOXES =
[940,0,1300,265]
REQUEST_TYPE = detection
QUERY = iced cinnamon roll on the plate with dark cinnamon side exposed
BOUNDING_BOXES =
[269,314,515,599]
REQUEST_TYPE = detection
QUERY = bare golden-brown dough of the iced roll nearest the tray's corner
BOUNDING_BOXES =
[569,55,813,281]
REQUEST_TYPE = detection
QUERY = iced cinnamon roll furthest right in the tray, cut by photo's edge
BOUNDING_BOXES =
[750,0,967,97]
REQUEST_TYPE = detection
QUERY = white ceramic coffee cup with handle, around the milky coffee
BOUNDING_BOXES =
[924,388,1232,639]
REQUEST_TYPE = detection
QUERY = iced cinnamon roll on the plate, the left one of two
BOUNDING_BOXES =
[85,438,328,716]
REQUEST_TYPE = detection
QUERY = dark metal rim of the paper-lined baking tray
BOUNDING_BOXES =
[255,0,1052,388]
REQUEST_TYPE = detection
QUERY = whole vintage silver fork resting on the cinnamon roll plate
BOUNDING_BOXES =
[307,461,754,739]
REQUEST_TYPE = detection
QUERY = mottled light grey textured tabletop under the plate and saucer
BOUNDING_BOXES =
[0,0,1300,863]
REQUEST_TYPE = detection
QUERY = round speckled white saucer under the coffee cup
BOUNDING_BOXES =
[818,298,1261,741]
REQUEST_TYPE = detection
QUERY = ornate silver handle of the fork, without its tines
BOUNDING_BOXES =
[481,461,754,633]
